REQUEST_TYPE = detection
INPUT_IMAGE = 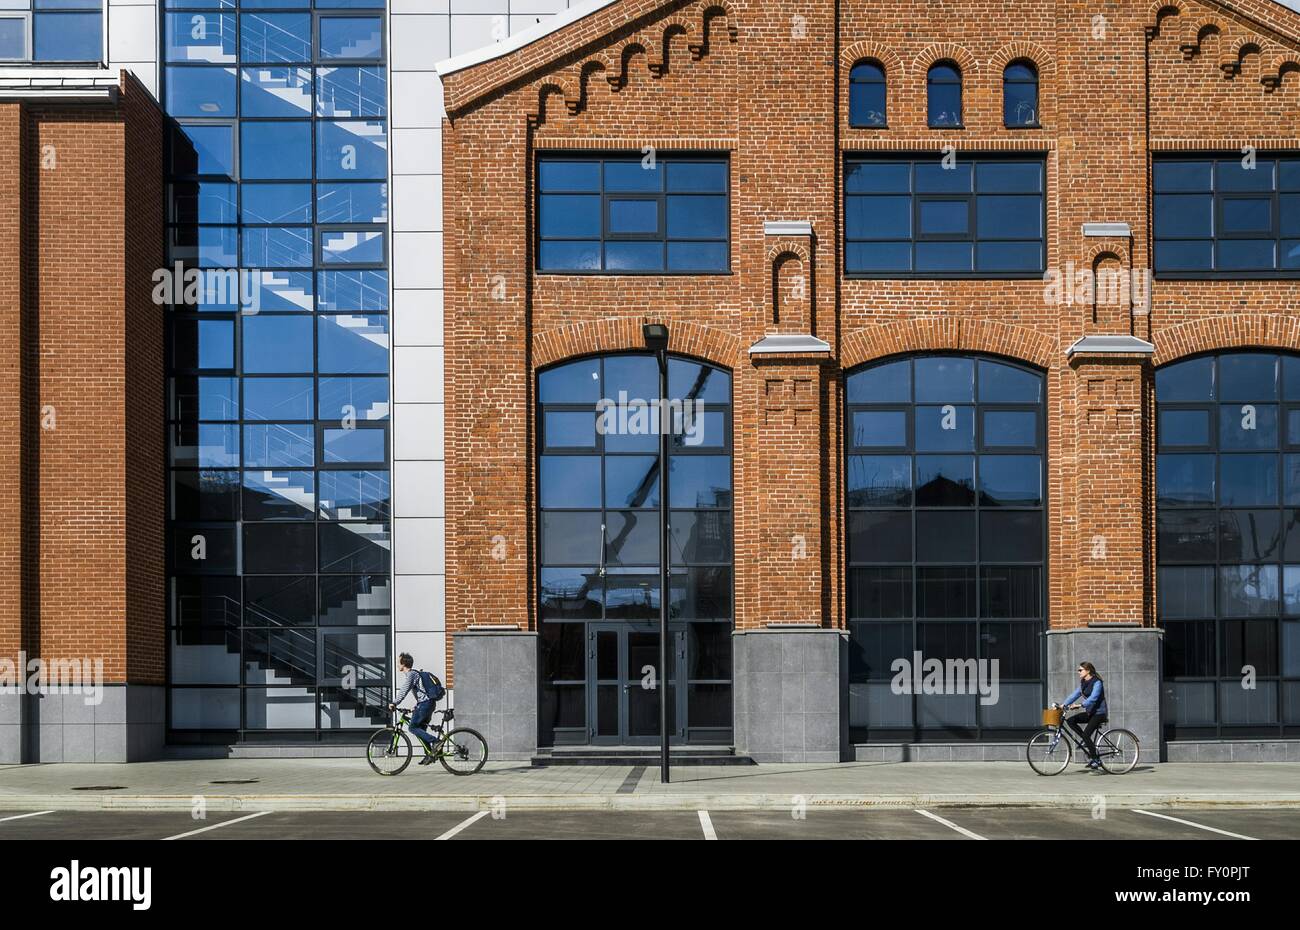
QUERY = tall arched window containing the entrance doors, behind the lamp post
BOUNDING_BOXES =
[537,354,733,745]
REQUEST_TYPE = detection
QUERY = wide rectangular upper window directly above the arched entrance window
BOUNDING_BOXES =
[537,156,731,274]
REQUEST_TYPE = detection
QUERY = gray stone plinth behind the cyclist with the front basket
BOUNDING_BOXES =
[1048,624,1165,762]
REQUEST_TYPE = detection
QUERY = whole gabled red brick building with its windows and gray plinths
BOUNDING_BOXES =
[439,0,1300,761]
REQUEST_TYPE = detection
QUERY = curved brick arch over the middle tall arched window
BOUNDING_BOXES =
[840,316,1057,368]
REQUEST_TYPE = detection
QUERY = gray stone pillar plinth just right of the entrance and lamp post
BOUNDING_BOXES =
[732,627,850,762]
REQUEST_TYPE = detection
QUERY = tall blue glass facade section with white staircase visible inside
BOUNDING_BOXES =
[161,0,391,740]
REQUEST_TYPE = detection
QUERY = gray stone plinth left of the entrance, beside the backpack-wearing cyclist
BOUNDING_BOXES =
[452,630,537,760]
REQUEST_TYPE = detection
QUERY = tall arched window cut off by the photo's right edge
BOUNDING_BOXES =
[1156,351,1300,737]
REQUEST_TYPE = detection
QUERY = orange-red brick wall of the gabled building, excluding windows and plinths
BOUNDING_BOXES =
[443,0,1300,676]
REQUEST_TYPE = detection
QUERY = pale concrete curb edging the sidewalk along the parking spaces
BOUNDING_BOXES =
[0,792,1300,812]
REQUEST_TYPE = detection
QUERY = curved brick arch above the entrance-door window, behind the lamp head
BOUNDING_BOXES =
[533,315,745,371]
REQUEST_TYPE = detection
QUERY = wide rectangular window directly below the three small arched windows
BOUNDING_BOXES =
[844,156,1047,277]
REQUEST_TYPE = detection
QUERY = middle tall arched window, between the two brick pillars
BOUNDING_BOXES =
[845,355,1045,741]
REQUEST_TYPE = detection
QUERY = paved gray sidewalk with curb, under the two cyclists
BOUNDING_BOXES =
[0,758,1300,810]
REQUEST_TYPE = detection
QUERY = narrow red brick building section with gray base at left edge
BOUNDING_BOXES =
[0,69,165,762]
